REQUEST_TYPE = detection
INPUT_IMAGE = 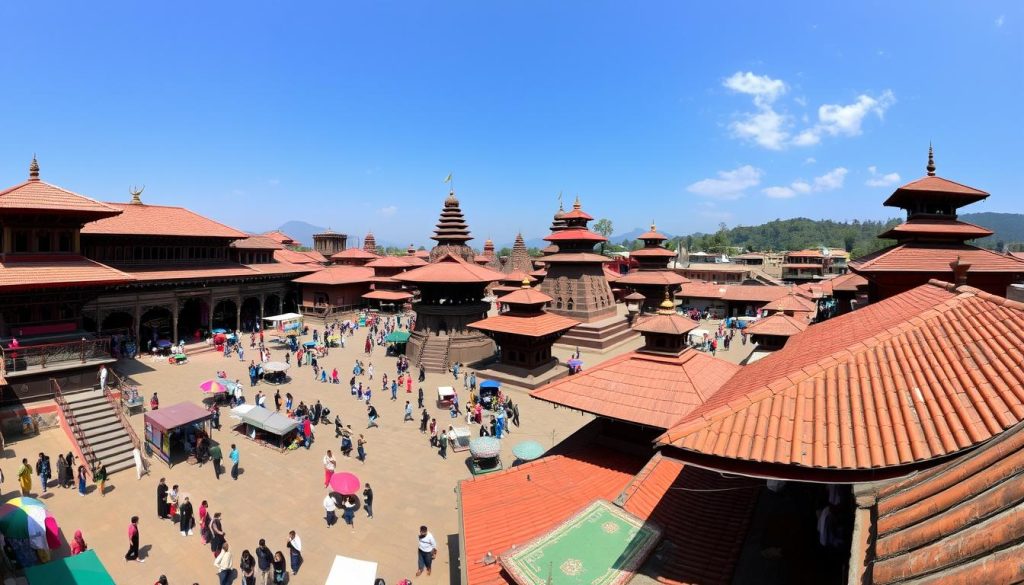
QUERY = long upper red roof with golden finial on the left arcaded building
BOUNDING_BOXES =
[82,203,248,239]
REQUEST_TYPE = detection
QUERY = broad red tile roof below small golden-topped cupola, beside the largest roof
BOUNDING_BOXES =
[529,349,740,428]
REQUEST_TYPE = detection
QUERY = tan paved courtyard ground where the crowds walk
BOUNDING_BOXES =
[3,315,750,585]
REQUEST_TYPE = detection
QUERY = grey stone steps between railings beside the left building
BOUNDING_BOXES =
[65,389,135,473]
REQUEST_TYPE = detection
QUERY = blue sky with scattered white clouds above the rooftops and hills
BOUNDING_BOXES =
[0,1,1024,246]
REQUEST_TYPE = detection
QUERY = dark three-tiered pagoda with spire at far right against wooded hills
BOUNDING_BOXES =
[850,147,1024,302]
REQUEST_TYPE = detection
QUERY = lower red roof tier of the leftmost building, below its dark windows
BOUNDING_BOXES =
[0,255,135,291]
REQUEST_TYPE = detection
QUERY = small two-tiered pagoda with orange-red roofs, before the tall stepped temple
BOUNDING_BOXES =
[469,275,580,388]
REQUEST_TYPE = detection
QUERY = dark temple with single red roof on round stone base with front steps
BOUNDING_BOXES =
[394,254,502,372]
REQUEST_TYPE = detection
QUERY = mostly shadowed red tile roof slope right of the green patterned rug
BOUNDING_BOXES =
[618,454,764,585]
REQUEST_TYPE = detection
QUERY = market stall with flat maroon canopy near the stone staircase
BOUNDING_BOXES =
[143,403,213,466]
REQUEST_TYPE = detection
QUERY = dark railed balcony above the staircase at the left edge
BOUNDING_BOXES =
[0,337,114,383]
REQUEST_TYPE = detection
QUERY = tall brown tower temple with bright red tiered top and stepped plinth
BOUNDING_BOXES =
[540,198,635,349]
